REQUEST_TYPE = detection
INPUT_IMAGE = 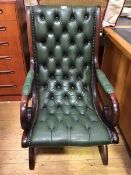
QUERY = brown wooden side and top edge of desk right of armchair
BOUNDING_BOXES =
[102,28,131,149]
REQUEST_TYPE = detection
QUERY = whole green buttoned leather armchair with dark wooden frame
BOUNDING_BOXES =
[20,5,119,169]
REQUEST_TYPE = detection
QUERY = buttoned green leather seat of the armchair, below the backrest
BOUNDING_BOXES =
[30,107,111,146]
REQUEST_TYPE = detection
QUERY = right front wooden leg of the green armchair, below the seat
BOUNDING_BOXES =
[98,145,108,165]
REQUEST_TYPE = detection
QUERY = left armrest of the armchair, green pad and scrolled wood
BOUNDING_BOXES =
[20,70,34,130]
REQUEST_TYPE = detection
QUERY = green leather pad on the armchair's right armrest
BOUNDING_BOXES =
[96,69,115,94]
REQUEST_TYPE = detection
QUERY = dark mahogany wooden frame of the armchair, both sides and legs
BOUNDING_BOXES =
[20,7,119,170]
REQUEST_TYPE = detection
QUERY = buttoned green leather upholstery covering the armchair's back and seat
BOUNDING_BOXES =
[29,6,111,146]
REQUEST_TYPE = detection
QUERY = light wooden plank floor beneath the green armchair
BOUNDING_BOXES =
[0,102,131,175]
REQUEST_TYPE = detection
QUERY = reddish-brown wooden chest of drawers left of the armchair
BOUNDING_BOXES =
[0,0,29,101]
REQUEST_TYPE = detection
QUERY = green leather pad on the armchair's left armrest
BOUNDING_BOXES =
[22,70,34,96]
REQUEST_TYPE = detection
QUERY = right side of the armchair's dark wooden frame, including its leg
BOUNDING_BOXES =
[93,8,120,165]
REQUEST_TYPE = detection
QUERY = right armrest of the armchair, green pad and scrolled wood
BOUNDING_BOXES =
[96,69,120,126]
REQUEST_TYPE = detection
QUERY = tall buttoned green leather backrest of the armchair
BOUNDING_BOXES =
[31,6,97,113]
